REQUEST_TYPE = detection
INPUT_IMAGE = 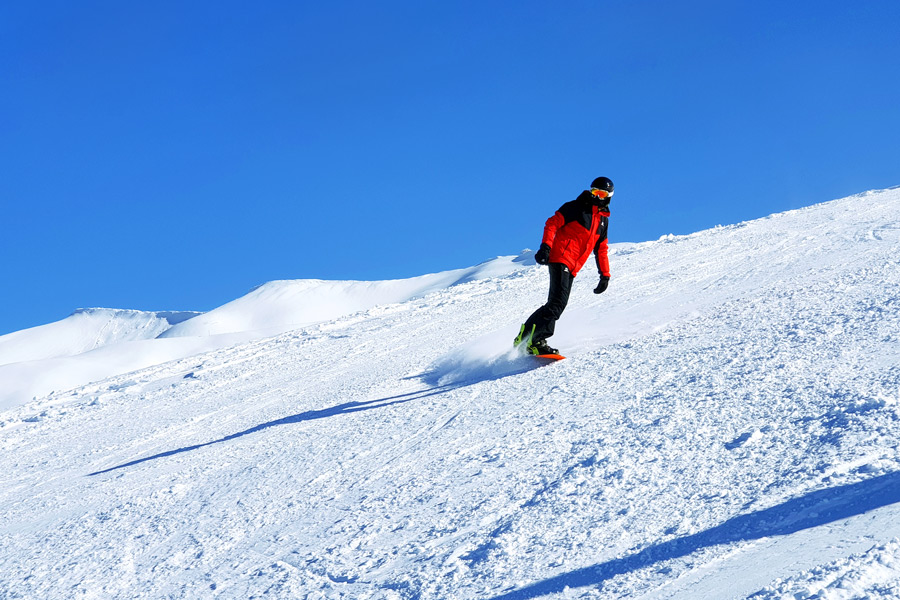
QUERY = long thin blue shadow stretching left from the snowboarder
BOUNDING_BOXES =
[88,383,470,477]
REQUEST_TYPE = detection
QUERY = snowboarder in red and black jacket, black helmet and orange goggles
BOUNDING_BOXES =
[513,177,614,355]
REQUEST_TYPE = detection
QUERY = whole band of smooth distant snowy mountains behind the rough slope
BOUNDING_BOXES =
[0,250,534,410]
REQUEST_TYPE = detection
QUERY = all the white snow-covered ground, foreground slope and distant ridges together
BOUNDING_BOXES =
[0,189,900,600]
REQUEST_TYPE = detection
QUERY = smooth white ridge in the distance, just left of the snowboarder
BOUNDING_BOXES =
[160,250,534,338]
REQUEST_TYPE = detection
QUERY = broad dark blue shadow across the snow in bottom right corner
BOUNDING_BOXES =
[492,472,900,600]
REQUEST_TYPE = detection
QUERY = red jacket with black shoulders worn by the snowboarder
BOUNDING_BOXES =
[541,191,609,277]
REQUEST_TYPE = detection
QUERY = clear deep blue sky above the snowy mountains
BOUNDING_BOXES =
[0,0,900,334]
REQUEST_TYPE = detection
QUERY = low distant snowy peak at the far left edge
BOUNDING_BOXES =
[0,308,200,365]
